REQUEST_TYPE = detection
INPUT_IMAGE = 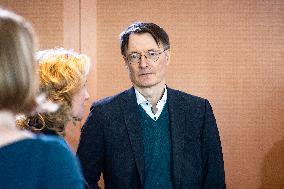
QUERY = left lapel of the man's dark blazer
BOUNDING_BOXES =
[120,87,144,188]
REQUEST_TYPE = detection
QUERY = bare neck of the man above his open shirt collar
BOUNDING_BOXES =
[134,83,165,107]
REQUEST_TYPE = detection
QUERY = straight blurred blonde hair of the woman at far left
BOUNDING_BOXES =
[0,7,38,113]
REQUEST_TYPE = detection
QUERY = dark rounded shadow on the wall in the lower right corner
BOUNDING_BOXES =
[258,139,284,189]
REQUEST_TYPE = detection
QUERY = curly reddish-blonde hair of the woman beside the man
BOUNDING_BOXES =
[17,48,90,136]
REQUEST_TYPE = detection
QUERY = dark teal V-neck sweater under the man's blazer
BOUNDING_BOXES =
[139,103,173,189]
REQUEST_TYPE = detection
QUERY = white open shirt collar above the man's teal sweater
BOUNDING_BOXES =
[134,86,167,121]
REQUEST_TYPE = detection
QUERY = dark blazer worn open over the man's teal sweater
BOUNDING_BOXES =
[77,88,225,189]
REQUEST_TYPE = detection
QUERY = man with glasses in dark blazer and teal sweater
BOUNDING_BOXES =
[77,22,225,189]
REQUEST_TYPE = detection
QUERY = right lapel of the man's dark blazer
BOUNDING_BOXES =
[167,88,188,188]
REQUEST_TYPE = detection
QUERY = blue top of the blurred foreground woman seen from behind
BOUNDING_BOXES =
[0,135,84,189]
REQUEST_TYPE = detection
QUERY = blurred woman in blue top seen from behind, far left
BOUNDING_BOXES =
[0,7,84,189]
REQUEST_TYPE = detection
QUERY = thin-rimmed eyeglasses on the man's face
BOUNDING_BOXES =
[126,48,168,64]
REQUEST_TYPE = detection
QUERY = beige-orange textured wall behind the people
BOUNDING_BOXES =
[0,0,284,189]
